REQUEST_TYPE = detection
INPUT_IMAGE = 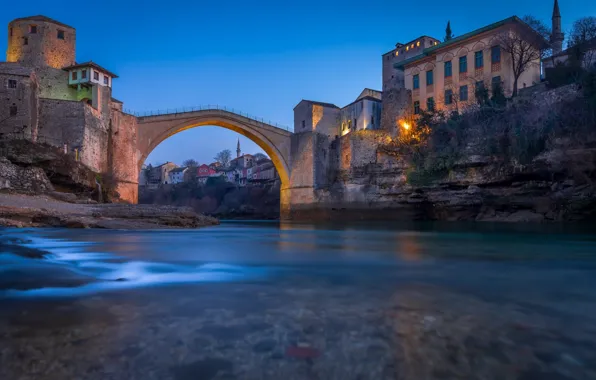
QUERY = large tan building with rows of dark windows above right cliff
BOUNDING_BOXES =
[395,16,546,114]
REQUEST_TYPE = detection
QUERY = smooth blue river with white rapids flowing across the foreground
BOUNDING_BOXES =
[0,222,596,380]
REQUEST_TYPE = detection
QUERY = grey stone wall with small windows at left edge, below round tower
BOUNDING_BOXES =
[0,64,38,140]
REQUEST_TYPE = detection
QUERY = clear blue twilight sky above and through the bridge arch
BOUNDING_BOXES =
[0,0,596,164]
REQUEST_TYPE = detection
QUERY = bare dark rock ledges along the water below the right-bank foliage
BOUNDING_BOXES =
[308,147,596,222]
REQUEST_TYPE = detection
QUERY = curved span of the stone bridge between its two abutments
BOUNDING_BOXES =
[137,109,292,190]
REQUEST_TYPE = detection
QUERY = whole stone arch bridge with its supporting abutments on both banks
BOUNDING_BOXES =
[113,108,325,219]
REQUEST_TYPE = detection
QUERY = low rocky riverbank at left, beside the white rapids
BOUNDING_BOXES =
[0,194,219,229]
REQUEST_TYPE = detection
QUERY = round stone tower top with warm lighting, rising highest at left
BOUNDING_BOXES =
[6,16,76,69]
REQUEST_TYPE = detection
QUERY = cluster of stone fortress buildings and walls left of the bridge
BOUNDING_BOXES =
[0,16,138,201]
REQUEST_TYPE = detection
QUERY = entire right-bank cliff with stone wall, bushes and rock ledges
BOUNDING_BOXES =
[302,84,596,222]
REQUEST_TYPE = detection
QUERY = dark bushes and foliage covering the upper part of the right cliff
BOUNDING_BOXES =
[386,71,596,185]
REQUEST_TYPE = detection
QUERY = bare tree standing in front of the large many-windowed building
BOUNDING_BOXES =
[497,19,548,96]
